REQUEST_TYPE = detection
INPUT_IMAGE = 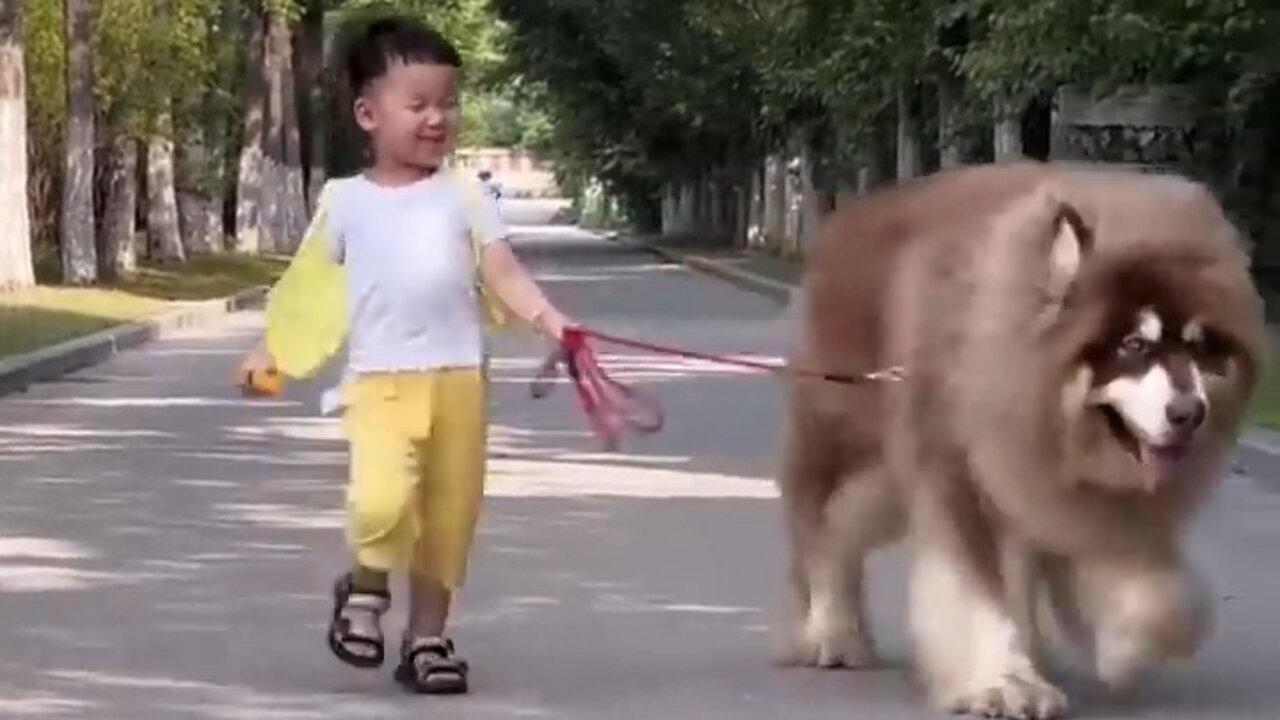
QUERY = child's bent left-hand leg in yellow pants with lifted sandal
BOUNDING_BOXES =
[329,378,425,667]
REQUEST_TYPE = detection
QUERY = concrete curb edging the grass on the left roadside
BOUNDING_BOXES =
[0,286,269,397]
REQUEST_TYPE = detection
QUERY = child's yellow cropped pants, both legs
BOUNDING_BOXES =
[342,368,486,588]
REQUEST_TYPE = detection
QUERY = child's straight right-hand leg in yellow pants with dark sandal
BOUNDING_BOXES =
[397,370,485,693]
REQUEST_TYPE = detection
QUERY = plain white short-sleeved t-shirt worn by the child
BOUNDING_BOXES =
[328,170,507,373]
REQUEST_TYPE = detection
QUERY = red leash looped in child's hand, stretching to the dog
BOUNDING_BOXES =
[529,327,906,451]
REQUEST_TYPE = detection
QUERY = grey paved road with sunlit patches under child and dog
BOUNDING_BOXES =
[0,198,1280,720]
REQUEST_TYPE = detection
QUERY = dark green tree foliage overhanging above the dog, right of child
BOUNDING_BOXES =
[494,0,1277,224]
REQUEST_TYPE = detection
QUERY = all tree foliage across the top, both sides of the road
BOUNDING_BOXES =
[10,0,1280,281]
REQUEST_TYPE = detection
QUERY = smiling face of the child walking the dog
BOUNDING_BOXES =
[356,63,458,169]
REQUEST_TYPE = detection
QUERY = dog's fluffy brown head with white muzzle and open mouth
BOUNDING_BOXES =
[1048,190,1262,492]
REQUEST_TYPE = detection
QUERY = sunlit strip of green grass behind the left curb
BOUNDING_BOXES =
[0,255,288,357]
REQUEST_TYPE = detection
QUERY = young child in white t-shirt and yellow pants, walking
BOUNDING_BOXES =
[242,18,576,693]
